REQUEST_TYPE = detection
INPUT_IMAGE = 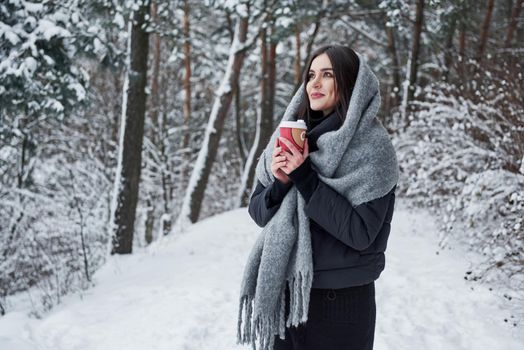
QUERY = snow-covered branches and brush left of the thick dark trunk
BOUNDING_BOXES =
[0,0,124,314]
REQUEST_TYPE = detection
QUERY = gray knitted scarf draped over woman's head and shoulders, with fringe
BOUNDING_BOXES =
[237,54,399,350]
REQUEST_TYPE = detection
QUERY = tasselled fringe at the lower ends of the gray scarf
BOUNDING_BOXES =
[237,272,313,350]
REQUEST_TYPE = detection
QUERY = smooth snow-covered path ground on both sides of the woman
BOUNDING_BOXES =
[0,208,524,350]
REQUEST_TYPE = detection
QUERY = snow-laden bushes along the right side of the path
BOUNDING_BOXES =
[395,67,524,288]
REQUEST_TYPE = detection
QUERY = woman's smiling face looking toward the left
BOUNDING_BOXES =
[306,53,338,115]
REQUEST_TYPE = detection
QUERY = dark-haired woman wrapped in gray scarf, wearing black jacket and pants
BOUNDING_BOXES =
[238,45,398,350]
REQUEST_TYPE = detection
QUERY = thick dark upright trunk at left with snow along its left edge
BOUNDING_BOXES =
[111,1,150,254]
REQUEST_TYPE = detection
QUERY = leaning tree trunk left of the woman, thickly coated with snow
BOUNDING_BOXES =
[175,7,249,227]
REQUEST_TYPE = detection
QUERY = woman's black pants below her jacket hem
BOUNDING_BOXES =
[273,282,376,350]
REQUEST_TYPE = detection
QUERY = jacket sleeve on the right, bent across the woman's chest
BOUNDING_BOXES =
[289,157,396,251]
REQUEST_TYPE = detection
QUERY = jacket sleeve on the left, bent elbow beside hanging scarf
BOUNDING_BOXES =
[248,180,293,227]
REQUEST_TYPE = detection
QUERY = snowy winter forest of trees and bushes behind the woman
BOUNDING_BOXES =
[0,0,524,348]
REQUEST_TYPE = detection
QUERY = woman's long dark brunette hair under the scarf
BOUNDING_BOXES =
[298,45,360,126]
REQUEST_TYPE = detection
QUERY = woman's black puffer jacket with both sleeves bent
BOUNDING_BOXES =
[249,114,396,289]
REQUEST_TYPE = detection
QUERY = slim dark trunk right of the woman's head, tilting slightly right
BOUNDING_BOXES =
[403,0,424,126]
